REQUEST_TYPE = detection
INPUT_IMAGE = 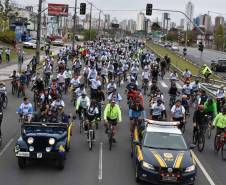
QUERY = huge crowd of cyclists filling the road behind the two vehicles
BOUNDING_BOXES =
[0,39,226,152]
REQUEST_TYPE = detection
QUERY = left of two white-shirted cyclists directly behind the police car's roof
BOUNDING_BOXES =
[150,99,167,121]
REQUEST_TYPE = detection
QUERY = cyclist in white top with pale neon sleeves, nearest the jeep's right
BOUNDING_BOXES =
[76,91,90,119]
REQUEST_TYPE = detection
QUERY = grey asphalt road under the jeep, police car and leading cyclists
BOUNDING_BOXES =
[0,53,226,185]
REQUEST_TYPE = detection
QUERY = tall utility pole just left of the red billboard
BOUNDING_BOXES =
[36,0,42,63]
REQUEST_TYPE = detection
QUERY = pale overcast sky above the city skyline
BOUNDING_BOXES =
[12,0,226,23]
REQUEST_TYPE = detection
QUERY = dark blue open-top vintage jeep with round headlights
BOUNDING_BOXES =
[15,122,72,169]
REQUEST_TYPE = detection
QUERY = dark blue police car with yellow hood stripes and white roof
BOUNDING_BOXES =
[134,120,197,185]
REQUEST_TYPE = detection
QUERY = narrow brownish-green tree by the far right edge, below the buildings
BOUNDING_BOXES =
[214,25,224,50]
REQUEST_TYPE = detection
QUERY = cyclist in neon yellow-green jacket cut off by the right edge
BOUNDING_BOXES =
[213,106,226,136]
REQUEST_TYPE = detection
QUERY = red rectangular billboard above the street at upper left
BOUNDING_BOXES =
[48,3,68,17]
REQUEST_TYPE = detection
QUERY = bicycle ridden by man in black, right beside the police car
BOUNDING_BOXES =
[193,125,206,152]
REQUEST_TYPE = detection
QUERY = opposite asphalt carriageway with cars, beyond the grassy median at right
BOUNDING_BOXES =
[179,47,226,77]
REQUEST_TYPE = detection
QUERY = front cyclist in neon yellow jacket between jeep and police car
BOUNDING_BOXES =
[104,99,122,142]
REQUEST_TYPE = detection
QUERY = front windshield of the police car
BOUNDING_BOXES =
[144,132,187,150]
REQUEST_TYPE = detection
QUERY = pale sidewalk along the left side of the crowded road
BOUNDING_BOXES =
[0,48,59,81]
